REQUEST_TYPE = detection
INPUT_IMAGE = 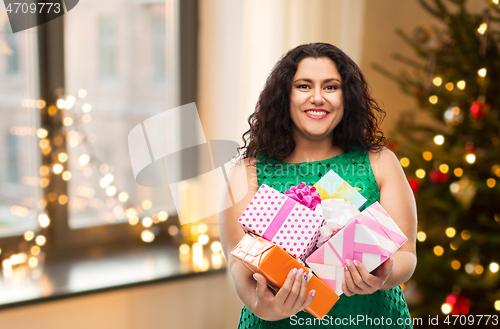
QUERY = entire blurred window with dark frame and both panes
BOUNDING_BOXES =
[0,0,197,258]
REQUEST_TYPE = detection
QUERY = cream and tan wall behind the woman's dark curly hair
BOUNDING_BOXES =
[197,0,365,142]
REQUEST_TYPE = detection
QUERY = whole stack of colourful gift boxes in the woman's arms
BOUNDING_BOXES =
[232,170,407,318]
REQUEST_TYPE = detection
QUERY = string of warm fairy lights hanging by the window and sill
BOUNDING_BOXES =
[0,89,222,276]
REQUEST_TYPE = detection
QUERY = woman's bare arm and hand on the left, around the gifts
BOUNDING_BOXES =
[219,159,314,321]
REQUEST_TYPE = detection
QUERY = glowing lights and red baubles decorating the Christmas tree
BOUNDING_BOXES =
[399,7,500,314]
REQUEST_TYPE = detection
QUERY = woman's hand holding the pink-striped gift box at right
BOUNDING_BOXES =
[342,257,394,297]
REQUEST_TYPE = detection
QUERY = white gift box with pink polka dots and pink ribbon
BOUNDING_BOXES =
[239,184,324,260]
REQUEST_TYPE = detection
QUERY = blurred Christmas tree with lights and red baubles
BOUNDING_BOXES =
[374,0,500,325]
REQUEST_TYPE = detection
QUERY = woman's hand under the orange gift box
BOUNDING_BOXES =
[253,268,316,321]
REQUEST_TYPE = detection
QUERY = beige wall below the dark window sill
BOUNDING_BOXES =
[0,274,242,329]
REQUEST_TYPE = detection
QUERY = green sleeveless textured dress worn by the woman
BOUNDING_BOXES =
[238,147,412,329]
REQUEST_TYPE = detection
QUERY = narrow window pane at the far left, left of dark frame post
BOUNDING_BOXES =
[0,22,41,237]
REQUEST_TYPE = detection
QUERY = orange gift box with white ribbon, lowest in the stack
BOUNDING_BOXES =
[231,233,339,319]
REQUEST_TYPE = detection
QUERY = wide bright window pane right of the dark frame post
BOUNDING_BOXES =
[64,1,178,229]
